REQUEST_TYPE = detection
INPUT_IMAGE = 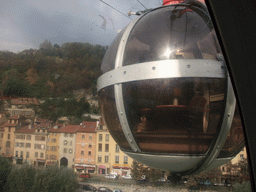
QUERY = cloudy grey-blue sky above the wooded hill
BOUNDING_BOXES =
[0,0,162,53]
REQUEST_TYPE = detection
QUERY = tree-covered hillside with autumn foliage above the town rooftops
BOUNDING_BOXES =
[0,40,107,99]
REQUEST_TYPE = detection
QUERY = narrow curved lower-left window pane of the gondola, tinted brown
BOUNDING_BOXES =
[99,86,131,150]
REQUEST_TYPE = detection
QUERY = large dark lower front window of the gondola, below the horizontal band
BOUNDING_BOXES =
[123,78,226,154]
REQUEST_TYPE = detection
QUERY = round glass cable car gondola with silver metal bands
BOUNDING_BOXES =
[98,3,244,174]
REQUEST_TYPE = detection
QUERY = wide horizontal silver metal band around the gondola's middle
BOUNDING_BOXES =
[98,59,225,91]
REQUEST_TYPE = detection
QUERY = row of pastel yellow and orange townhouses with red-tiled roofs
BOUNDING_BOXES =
[0,115,132,175]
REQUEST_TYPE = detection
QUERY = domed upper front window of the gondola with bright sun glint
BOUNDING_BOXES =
[123,6,221,65]
